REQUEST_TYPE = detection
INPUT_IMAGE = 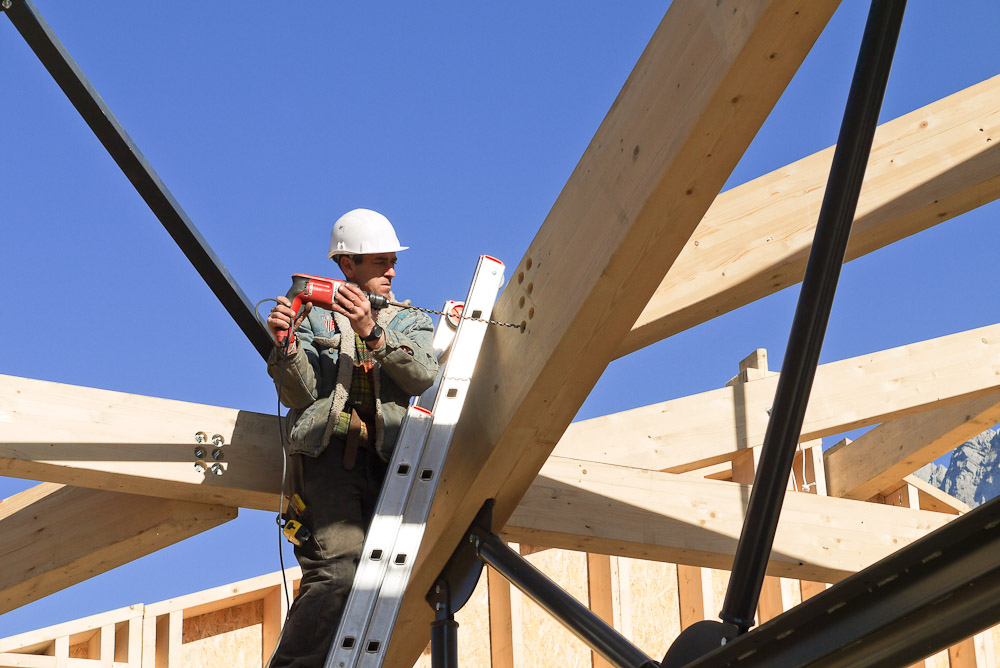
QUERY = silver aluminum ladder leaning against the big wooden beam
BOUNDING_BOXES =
[324,255,504,668]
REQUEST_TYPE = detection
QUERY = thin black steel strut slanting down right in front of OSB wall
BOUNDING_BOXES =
[473,533,659,668]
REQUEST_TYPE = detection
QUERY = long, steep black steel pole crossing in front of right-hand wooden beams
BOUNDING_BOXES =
[720,0,906,631]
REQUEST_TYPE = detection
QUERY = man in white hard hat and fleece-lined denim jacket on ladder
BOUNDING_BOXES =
[267,209,438,668]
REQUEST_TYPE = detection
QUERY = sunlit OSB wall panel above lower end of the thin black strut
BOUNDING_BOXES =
[621,559,681,661]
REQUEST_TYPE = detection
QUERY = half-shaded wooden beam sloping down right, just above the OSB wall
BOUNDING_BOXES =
[501,457,953,582]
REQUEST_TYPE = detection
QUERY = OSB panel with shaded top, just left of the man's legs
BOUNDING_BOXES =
[181,600,264,668]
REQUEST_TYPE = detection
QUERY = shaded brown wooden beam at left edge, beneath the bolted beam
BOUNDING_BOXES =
[0,483,236,613]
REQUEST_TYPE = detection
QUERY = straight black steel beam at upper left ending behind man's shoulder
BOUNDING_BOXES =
[0,0,274,359]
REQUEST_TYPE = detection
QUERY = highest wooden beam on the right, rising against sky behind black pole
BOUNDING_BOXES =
[617,76,1000,356]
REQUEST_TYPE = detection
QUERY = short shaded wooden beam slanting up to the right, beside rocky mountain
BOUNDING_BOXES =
[823,394,1000,499]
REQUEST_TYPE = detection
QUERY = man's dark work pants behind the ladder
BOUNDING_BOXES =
[271,440,386,668]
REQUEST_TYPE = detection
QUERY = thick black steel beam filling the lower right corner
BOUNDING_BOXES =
[685,498,1000,668]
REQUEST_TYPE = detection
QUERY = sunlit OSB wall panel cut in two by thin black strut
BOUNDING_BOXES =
[520,549,590,668]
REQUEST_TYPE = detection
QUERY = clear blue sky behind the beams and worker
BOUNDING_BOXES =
[0,0,1000,636]
